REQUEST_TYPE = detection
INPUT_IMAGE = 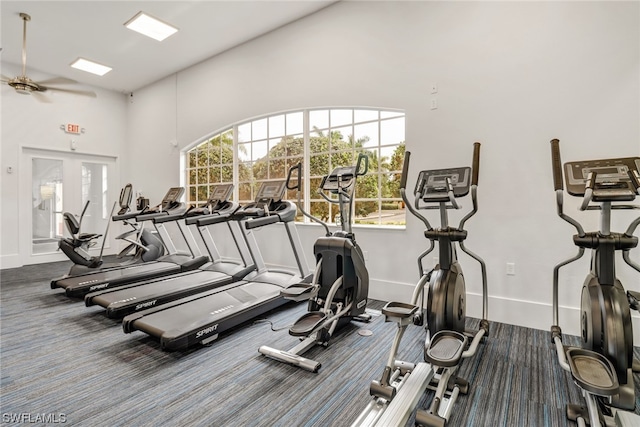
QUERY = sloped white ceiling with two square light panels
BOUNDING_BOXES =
[0,0,335,93]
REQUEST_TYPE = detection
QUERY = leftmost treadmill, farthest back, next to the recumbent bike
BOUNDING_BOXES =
[51,187,209,298]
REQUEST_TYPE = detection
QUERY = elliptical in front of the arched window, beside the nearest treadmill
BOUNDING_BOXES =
[258,154,371,372]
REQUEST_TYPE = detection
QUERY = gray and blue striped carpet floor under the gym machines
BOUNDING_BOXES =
[0,262,640,427]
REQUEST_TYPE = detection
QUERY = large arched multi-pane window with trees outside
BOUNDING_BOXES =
[185,107,405,226]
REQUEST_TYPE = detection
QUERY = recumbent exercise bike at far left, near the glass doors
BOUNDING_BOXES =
[58,184,164,276]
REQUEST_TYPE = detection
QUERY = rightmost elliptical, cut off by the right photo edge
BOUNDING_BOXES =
[551,139,640,426]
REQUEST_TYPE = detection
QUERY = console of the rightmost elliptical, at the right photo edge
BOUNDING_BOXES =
[564,157,640,201]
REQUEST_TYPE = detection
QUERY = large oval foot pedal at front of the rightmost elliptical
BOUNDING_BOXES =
[567,348,620,396]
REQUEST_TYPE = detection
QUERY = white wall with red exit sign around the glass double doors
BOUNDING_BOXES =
[0,63,129,268]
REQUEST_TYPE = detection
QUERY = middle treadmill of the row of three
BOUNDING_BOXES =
[84,184,255,318]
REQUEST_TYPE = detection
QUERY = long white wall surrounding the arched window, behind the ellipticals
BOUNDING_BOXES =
[3,2,640,343]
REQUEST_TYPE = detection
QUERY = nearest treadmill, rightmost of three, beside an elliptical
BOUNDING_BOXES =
[122,180,311,350]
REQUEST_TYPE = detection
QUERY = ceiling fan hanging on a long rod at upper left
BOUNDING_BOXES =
[1,13,96,102]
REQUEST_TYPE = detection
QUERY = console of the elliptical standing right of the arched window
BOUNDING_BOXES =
[414,167,471,202]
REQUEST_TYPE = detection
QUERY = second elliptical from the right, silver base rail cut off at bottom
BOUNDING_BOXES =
[352,142,489,427]
